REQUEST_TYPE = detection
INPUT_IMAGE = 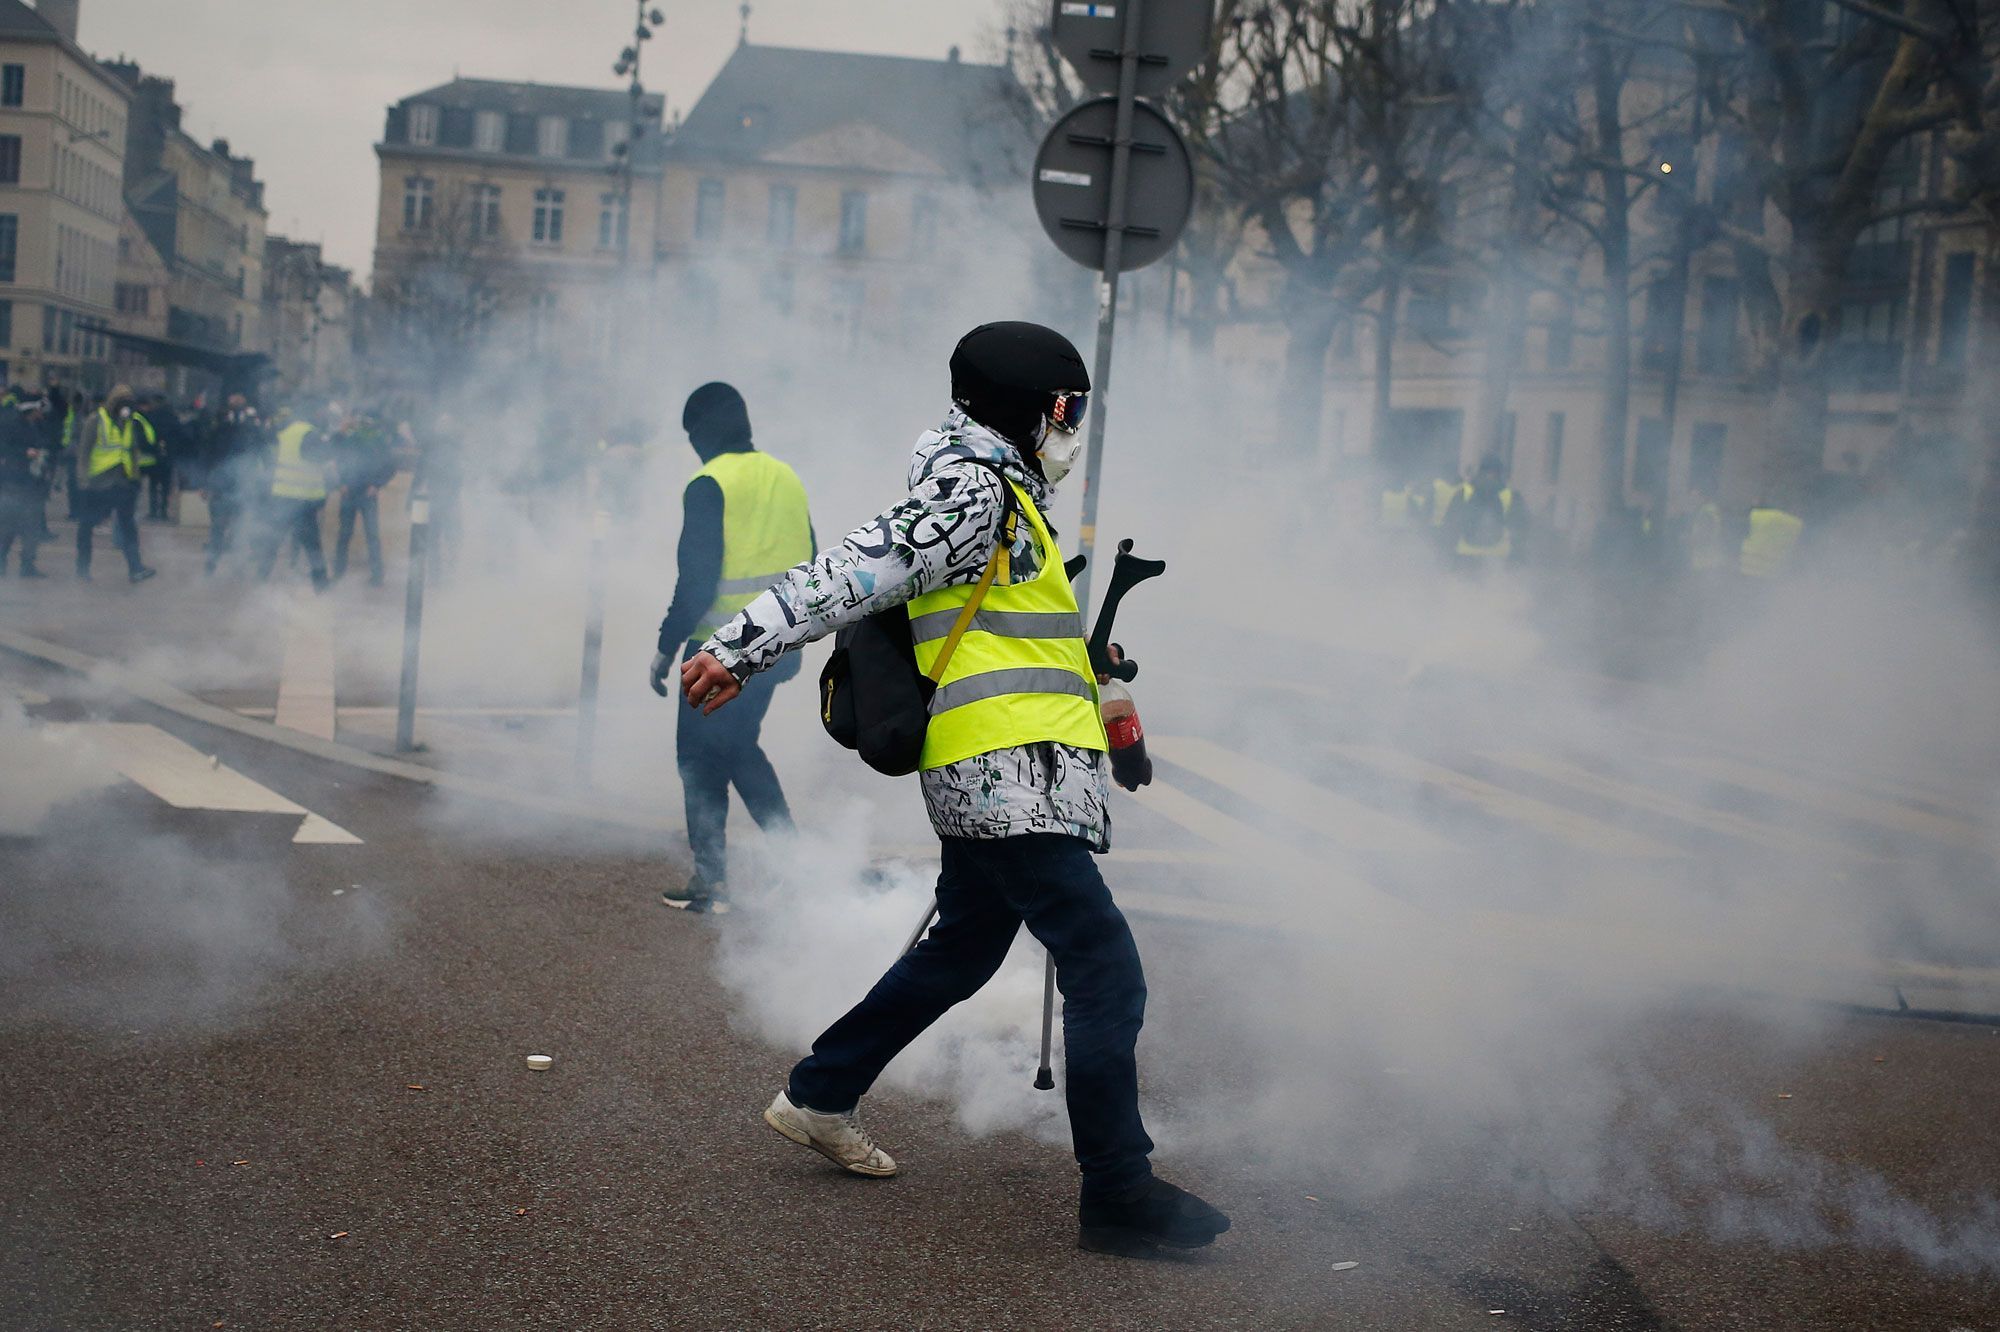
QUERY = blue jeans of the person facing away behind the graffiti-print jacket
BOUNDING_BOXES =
[674,648,792,890]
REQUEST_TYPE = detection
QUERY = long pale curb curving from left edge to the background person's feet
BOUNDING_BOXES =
[0,630,682,836]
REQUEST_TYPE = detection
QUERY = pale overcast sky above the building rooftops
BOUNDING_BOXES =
[80,0,1000,280]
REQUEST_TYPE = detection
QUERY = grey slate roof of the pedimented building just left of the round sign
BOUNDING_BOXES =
[664,44,1032,176]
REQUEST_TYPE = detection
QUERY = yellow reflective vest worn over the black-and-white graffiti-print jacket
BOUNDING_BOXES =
[910,480,1110,770]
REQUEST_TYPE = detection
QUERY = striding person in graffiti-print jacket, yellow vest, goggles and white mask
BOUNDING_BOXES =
[680,324,1230,1256]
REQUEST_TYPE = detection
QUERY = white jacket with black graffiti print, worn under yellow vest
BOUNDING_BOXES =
[702,412,1110,850]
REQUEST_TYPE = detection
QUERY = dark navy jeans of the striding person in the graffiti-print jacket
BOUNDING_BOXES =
[788,832,1152,1200]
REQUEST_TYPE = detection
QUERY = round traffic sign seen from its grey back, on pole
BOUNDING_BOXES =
[1034,98,1194,272]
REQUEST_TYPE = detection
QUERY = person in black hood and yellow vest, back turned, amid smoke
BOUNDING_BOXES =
[652,384,814,914]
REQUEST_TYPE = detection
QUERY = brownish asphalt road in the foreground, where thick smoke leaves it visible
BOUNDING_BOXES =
[0,662,2000,1332]
